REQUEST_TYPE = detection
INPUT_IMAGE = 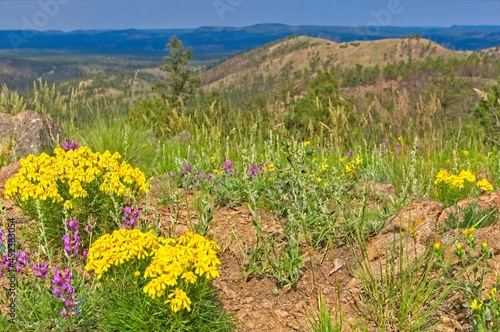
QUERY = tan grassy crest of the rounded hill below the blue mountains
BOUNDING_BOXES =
[203,37,460,89]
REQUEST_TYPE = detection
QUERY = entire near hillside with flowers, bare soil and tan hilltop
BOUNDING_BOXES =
[0,37,500,331]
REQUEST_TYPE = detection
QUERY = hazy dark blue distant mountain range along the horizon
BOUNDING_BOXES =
[0,24,500,60]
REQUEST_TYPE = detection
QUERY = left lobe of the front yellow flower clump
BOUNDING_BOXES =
[85,228,160,279]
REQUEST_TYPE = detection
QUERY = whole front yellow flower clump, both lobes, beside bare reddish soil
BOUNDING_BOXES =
[85,229,220,312]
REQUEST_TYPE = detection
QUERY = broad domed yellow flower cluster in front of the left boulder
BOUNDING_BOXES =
[5,146,150,208]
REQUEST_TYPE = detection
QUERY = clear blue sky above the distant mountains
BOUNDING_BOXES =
[0,0,500,31]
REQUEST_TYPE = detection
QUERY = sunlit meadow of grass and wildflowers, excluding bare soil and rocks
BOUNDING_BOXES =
[0,71,500,331]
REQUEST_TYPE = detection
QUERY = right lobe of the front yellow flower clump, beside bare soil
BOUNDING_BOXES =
[144,232,220,298]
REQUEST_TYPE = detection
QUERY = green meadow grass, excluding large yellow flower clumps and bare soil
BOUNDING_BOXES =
[0,71,500,331]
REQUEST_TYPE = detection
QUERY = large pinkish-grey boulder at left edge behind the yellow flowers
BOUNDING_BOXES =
[0,111,65,158]
